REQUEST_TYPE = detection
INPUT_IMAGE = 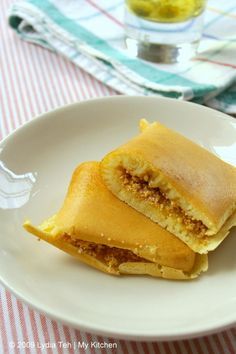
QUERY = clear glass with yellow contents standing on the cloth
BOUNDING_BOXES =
[125,0,206,63]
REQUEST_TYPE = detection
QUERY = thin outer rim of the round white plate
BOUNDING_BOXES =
[0,95,236,341]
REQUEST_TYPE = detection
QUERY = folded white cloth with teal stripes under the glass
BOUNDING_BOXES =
[9,0,236,114]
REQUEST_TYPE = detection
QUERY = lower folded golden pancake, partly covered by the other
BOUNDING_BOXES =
[24,162,207,279]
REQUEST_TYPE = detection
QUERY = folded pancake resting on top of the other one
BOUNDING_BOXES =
[101,120,236,253]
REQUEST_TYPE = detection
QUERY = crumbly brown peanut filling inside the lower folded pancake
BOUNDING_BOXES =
[63,235,148,267]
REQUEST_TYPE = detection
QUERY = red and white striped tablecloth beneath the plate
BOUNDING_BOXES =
[0,0,236,354]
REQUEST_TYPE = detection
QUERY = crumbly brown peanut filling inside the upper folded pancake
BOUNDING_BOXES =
[120,170,207,238]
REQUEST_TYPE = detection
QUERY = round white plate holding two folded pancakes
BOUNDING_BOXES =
[0,97,236,340]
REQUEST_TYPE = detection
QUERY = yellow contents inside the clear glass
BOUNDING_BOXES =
[126,0,206,22]
